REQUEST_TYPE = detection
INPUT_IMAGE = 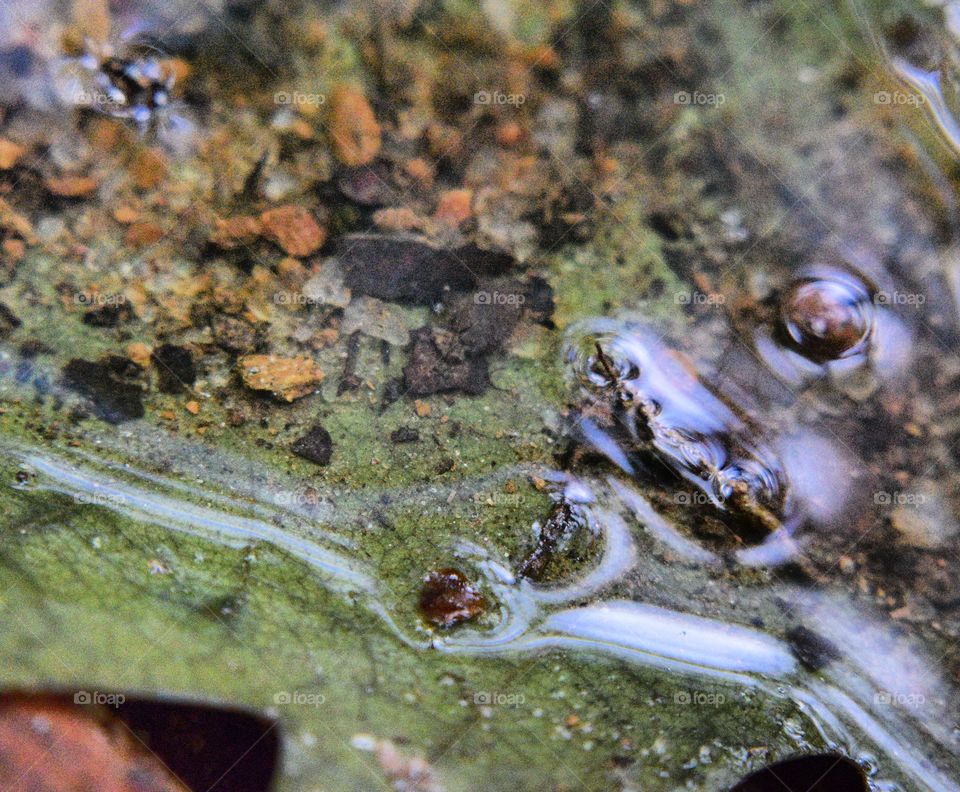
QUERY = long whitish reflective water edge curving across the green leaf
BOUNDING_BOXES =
[13,447,957,790]
